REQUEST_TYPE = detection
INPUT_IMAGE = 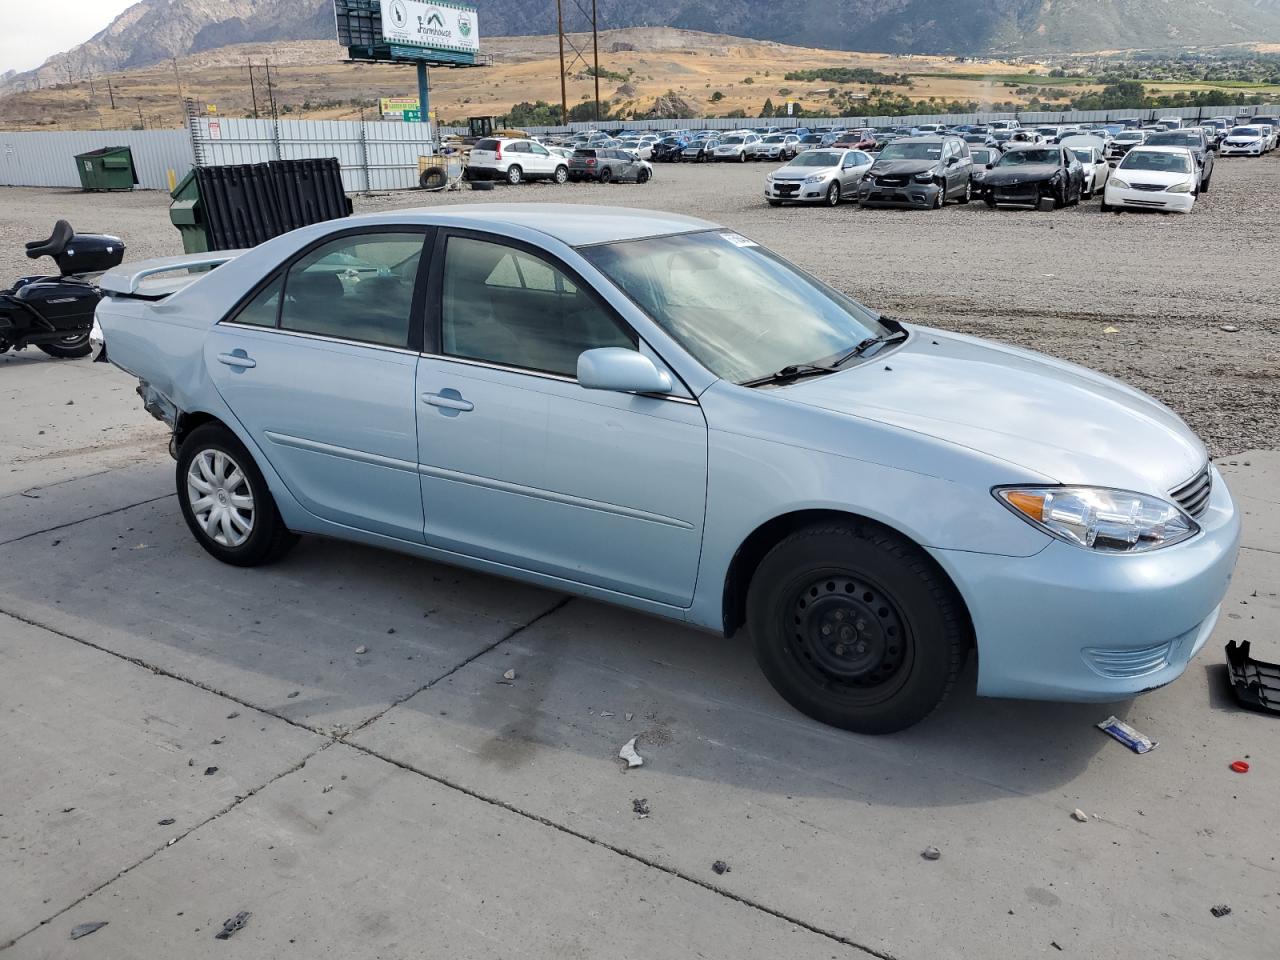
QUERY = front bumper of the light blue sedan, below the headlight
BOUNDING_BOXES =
[929,467,1240,703]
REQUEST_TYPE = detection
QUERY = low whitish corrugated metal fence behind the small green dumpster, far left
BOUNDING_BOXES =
[0,131,191,189]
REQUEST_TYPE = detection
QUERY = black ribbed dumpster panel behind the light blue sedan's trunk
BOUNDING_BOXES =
[170,156,352,250]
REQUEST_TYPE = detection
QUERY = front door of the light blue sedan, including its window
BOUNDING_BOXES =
[417,230,707,607]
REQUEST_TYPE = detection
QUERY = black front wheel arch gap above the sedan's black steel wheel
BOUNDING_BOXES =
[722,509,974,646]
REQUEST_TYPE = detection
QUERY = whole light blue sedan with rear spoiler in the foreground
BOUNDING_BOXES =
[97,204,1239,733]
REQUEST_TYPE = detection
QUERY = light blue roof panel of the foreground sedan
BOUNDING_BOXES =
[349,204,719,247]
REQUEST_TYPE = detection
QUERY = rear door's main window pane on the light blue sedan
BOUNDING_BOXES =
[280,233,424,347]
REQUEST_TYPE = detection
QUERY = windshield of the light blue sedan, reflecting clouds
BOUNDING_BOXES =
[580,230,888,383]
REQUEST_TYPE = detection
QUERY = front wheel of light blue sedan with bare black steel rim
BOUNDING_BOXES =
[748,524,966,733]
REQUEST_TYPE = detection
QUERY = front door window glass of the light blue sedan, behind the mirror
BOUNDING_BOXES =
[440,237,636,376]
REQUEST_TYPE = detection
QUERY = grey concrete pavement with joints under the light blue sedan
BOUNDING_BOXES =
[0,360,1280,960]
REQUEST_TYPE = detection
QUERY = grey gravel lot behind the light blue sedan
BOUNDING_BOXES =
[0,152,1280,456]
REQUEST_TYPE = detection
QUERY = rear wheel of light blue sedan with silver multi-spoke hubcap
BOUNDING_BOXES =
[177,424,298,567]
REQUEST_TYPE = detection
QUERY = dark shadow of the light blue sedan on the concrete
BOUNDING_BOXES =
[0,488,1126,806]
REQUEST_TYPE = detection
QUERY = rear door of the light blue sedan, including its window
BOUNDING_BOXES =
[205,227,431,543]
